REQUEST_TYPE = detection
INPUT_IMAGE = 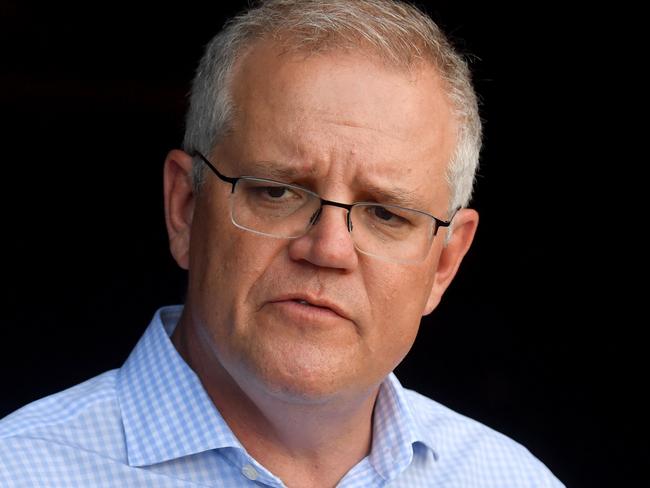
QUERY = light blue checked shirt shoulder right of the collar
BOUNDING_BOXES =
[405,390,564,488]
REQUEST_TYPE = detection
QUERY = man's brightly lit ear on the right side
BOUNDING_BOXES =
[423,208,478,315]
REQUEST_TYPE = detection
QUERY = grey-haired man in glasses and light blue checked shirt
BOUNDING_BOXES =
[0,0,561,487]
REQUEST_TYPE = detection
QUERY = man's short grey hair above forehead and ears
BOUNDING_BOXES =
[183,0,481,214]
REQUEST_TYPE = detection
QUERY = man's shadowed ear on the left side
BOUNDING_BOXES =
[164,149,194,269]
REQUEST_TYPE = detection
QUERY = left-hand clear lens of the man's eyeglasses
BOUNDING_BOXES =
[232,178,320,238]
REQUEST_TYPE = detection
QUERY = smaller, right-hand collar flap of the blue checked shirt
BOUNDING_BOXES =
[369,373,438,480]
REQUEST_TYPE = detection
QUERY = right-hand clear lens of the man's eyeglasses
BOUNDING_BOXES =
[350,203,435,262]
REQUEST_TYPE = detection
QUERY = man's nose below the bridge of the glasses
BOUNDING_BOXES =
[289,202,358,270]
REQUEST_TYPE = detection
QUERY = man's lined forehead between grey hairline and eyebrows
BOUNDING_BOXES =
[223,43,456,203]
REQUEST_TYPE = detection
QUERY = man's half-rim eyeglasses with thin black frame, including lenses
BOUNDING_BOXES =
[193,151,456,264]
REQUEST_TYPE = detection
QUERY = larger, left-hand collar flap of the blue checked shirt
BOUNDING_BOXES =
[117,306,243,466]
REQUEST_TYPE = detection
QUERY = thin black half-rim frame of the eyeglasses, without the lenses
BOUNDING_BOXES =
[192,151,461,260]
